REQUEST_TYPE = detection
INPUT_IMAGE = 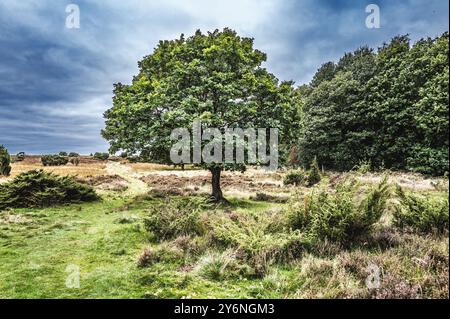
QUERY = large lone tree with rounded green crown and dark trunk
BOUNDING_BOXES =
[102,29,299,201]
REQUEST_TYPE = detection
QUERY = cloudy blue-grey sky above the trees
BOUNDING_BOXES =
[0,0,449,154]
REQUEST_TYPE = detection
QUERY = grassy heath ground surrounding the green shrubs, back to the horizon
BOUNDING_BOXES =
[0,161,449,298]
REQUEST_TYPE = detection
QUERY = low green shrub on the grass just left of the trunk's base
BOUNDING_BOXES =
[144,198,206,240]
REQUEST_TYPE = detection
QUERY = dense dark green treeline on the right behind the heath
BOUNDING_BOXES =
[291,32,449,175]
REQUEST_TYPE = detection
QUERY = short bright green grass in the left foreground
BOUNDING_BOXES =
[0,198,284,298]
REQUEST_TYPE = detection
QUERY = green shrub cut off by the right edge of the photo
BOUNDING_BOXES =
[394,186,449,233]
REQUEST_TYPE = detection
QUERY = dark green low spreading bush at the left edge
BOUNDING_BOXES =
[0,170,98,209]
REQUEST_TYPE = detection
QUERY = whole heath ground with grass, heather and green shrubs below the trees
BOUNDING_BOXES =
[0,157,449,298]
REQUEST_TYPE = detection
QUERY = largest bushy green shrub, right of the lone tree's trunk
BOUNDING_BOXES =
[288,178,390,243]
